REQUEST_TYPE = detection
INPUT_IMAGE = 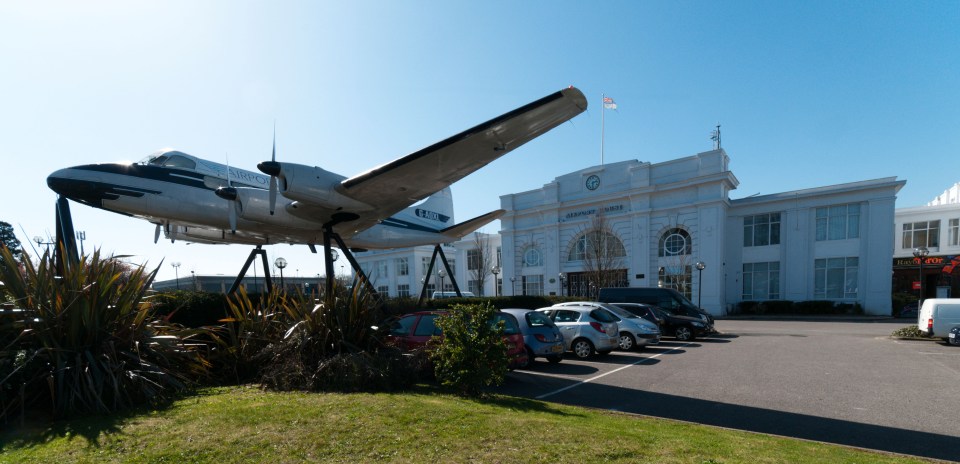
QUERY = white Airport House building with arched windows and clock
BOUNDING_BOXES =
[357,149,905,315]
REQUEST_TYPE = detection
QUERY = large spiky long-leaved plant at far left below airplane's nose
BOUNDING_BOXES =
[0,248,206,420]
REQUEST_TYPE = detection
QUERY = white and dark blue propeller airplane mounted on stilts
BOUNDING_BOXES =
[47,86,587,292]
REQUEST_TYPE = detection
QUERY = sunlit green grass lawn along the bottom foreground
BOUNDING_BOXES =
[0,387,929,464]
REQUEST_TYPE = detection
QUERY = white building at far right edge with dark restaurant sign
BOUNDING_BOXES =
[893,184,960,298]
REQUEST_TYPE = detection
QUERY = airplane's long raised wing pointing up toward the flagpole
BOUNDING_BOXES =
[338,87,587,217]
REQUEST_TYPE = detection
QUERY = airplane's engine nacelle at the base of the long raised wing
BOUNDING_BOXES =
[277,163,371,211]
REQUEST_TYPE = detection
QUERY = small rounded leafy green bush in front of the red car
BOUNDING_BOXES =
[430,303,509,396]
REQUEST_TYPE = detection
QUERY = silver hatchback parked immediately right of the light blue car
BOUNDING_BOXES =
[537,306,620,359]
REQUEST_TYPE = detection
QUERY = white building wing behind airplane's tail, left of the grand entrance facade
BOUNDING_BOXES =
[355,233,500,298]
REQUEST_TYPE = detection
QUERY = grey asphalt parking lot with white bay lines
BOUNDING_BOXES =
[499,320,960,460]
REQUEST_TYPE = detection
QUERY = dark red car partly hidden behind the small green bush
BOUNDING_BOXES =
[387,311,529,369]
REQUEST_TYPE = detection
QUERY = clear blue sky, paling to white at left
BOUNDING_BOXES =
[0,0,960,280]
